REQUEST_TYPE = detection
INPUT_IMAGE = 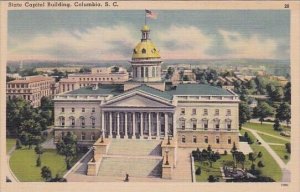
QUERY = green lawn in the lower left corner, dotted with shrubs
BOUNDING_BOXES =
[9,148,82,182]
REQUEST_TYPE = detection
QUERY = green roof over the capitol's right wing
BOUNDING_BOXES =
[170,84,234,95]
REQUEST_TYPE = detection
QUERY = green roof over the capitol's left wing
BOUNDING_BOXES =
[64,84,123,96]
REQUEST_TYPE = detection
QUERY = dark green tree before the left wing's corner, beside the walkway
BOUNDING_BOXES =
[56,132,77,169]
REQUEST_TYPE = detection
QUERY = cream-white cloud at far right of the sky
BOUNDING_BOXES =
[219,30,278,59]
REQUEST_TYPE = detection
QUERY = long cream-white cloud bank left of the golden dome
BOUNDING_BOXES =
[9,26,136,60]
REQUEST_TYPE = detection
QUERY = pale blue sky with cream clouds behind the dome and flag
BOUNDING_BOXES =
[8,10,290,60]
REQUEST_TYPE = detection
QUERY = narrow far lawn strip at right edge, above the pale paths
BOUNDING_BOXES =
[243,122,291,140]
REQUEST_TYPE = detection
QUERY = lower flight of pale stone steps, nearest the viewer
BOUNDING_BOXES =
[98,157,162,177]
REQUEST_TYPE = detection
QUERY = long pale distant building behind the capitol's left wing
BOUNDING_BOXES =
[59,66,129,93]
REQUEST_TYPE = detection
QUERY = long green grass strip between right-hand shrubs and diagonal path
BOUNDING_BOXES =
[240,129,282,182]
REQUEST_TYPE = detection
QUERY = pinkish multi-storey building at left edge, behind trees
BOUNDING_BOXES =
[6,75,57,107]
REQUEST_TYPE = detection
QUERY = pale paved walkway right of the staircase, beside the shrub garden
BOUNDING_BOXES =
[172,148,192,182]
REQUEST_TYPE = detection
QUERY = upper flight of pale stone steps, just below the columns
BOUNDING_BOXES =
[107,139,161,156]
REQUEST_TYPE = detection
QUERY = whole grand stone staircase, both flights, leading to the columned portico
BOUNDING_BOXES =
[98,139,162,177]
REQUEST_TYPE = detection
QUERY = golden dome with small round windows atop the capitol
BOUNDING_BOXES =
[132,39,160,59]
